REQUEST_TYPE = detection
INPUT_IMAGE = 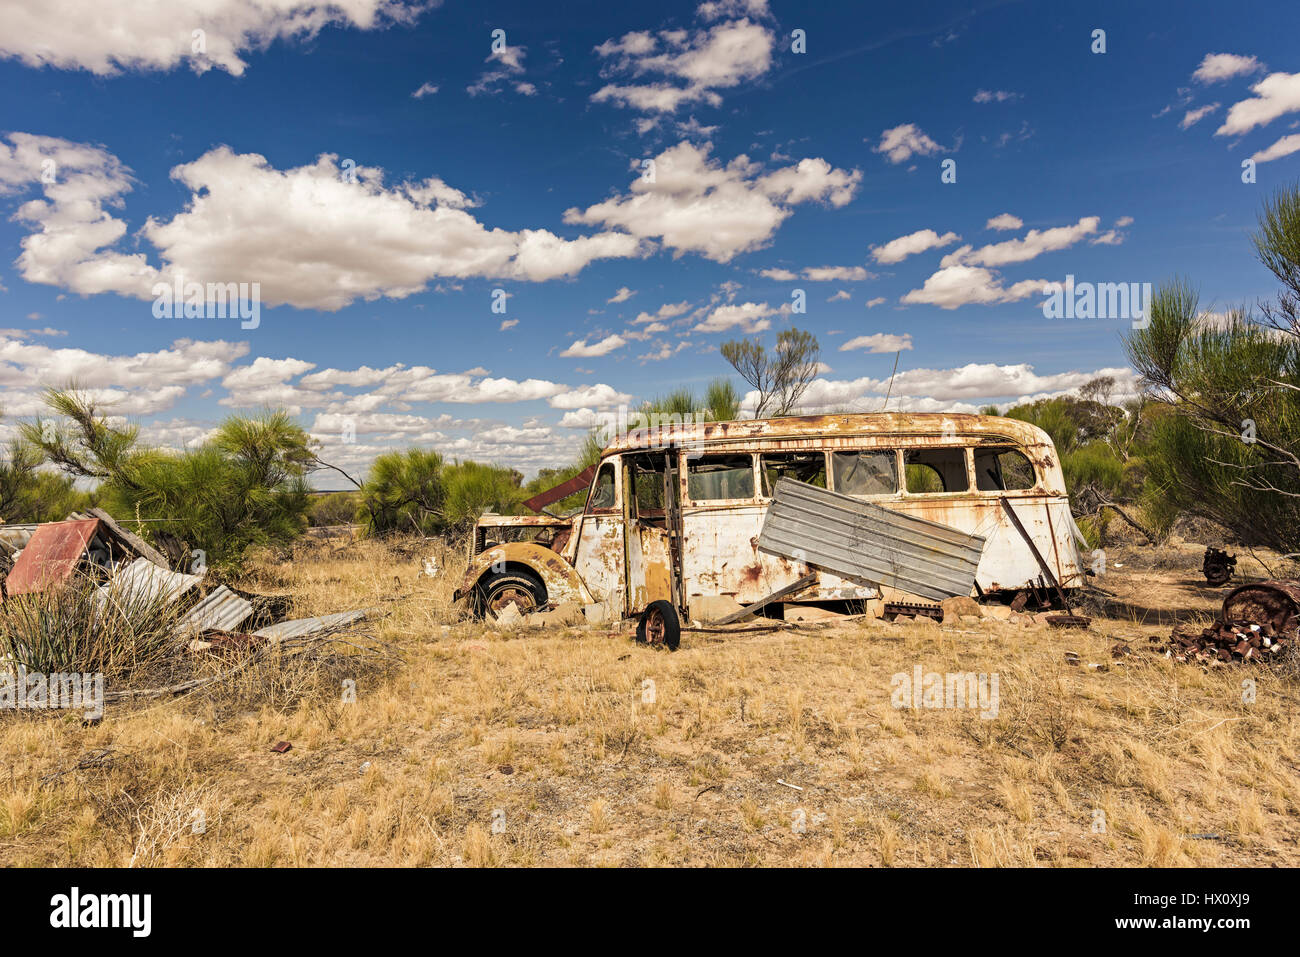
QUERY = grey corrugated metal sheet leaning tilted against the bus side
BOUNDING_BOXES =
[758,479,984,601]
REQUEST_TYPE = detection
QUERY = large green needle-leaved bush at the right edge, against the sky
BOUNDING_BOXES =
[1126,187,1300,554]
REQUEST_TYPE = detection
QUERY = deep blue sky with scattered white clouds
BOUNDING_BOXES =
[0,0,1300,472]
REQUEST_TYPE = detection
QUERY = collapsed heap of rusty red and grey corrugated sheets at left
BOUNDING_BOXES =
[0,508,376,651]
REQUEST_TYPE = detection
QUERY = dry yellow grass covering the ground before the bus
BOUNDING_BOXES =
[0,542,1300,866]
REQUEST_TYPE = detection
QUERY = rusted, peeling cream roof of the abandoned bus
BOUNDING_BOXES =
[605,412,1052,455]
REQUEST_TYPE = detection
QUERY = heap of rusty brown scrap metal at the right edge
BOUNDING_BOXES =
[1153,580,1300,664]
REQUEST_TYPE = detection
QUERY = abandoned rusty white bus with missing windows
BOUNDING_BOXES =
[456,412,1083,646]
